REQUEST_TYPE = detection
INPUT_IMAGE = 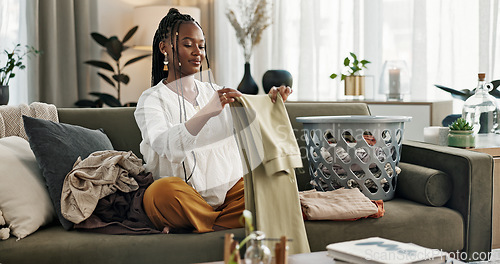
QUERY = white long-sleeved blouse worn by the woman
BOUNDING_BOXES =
[134,80,243,208]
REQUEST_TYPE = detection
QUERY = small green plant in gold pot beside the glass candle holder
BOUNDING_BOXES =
[330,52,370,98]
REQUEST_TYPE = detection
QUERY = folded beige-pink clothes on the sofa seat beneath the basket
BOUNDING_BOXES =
[299,188,378,220]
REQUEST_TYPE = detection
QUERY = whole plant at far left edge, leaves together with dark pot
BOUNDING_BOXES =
[0,44,40,105]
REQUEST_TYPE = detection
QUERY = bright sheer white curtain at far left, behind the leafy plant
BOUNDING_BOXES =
[0,0,29,105]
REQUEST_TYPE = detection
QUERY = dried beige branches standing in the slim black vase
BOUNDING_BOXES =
[226,0,272,62]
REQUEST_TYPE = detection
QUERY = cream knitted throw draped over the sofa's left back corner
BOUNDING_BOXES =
[0,102,59,140]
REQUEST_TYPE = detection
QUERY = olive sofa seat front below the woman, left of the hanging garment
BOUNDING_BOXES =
[0,226,246,264]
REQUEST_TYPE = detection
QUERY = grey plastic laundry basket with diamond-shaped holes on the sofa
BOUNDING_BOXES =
[297,116,411,201]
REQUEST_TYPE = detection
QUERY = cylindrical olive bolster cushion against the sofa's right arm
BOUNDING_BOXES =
[396,162,453,206]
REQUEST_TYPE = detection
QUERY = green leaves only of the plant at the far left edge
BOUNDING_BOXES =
[0,44,41,85]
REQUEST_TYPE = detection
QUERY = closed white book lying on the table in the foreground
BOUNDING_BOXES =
[326,237,448,264]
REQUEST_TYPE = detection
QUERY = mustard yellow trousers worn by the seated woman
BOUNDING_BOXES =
[143,177,245,233]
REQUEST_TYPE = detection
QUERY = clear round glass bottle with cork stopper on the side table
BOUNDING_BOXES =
[462,73,498,134]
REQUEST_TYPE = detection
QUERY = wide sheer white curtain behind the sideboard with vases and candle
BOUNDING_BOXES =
[214,0,500,103]
